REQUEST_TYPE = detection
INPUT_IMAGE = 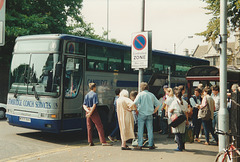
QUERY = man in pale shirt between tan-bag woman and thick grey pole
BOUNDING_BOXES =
[212,85,220,129]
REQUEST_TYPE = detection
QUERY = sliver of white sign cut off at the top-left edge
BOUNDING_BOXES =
[0,0,6,46]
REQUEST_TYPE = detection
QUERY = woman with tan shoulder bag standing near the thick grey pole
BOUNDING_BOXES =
[198,88,218,145]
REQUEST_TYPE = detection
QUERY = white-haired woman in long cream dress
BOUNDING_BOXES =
[117,89,135,150]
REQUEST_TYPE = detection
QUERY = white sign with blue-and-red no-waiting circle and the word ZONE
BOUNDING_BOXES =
[131,32,151,69]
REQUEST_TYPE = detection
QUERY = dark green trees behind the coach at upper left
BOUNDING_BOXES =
[0,0,122,66]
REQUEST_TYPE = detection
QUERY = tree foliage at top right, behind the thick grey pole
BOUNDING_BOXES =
[197,0,240,41]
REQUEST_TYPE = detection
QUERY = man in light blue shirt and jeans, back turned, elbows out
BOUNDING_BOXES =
[132,82,160,150]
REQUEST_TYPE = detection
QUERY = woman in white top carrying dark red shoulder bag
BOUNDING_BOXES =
[168,89,188,151]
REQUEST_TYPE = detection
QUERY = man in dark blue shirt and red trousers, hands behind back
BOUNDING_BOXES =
[83,83,110,146]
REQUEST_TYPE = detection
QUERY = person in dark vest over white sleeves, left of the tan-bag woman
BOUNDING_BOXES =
[189,88,202,142]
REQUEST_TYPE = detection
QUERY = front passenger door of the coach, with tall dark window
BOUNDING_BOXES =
[62,56,84,130]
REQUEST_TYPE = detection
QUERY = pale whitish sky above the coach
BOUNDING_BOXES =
[82,0,217,54]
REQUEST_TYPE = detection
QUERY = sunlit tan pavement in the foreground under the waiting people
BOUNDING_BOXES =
[0,133,218,162]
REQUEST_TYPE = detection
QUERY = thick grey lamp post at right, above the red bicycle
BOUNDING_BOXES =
[218,0,229,152]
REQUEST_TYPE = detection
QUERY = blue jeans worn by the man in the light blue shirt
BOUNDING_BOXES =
[138,114,153,147]
